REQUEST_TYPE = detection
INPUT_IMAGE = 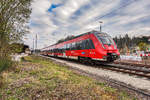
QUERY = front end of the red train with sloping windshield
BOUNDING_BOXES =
[96,33,120,62]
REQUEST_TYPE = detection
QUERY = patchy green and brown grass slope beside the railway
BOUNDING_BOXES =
[0,56,137,100]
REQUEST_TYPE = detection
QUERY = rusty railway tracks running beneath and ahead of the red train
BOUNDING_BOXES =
[42,57,150,79]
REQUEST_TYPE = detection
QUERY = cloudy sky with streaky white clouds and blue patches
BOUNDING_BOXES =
[24,0,150,49]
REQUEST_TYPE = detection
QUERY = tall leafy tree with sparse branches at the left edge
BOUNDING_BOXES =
[0,0,31,57]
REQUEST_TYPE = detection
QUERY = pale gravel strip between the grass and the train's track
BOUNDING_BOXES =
[51,58,150,91]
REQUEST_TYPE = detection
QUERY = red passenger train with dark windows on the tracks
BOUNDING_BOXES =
[41,31,120,62]
